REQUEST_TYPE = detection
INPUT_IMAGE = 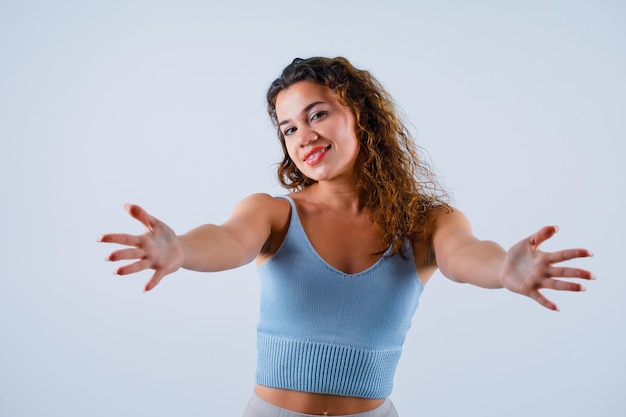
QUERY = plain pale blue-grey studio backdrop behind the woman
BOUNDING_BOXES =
[0,0,626,417]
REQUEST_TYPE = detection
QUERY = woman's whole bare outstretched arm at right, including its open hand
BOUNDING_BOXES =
[432,210,595,310]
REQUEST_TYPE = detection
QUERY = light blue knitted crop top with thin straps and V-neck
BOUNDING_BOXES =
[256,197,424,399]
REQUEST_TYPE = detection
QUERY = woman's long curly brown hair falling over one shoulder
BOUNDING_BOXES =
[267,57,451,255]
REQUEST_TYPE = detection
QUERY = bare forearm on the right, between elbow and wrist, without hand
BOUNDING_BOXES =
[440,240,506,288]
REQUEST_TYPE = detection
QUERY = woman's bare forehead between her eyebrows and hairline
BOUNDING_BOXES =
[276,81,339,121]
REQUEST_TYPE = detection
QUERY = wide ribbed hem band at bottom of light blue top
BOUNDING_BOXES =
[256,333,401,399]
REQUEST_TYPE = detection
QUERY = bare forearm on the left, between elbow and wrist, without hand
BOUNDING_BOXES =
[178,224,256,272]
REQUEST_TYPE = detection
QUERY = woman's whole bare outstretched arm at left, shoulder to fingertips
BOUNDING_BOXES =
[99,194,272,291]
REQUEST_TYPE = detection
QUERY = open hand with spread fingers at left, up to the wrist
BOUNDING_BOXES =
[98,204,185,291]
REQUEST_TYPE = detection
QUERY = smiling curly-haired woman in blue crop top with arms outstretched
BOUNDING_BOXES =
[100,58,594,417]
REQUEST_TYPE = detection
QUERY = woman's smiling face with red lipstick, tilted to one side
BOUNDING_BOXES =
[276,81,359,181]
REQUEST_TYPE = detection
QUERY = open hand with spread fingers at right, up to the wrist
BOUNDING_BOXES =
[500,226,595,311]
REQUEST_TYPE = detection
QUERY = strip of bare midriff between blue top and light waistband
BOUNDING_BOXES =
[254,385,385,416]
